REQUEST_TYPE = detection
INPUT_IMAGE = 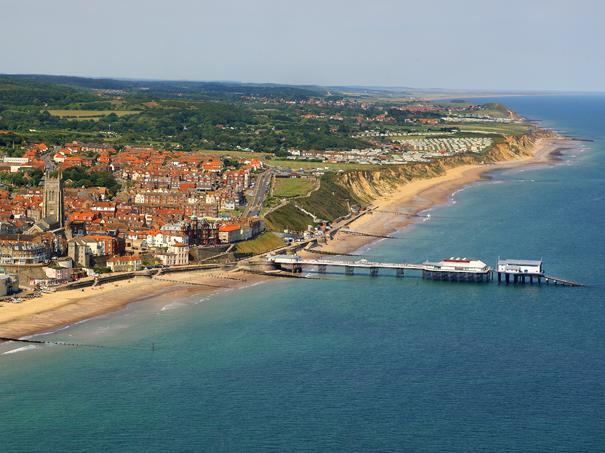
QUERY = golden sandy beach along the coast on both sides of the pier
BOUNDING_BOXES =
[0,136,574,344]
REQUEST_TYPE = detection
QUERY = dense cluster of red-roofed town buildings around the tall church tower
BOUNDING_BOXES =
[0,143,264,294]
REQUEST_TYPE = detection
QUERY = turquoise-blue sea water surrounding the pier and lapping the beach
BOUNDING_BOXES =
[0,96,605,452]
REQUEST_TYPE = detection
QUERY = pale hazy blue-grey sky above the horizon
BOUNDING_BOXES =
[0,0,605,91]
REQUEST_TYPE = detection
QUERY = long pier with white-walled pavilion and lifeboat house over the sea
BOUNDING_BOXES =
[267,255,583,286]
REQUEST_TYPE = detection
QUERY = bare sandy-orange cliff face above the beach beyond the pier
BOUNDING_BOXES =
[338,132,546,203]
